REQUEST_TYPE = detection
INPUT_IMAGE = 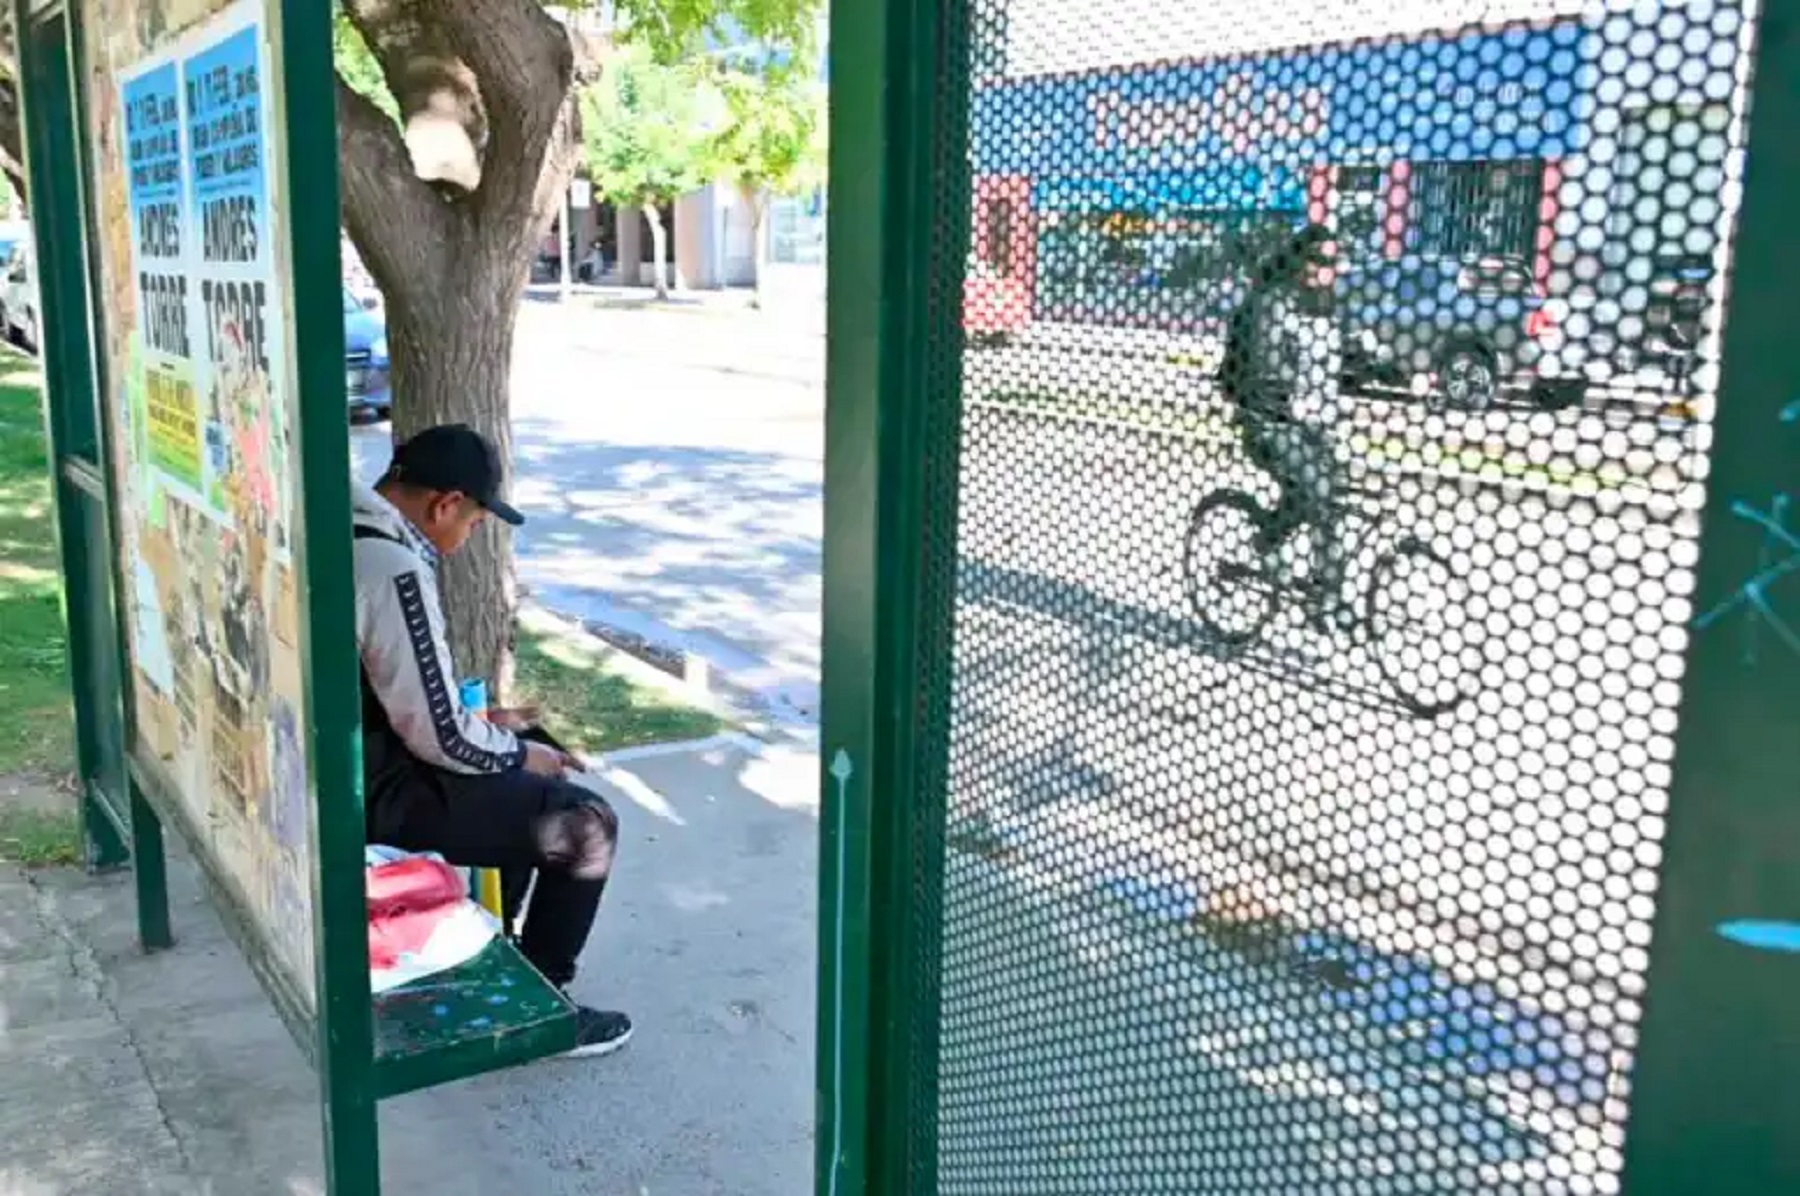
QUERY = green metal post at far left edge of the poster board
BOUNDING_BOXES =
[13,0,130,870]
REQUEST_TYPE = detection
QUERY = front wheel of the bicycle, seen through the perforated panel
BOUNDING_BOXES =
[1364,537,1481,719]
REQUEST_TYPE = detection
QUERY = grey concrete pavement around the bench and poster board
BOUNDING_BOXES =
[0,738,817,1196]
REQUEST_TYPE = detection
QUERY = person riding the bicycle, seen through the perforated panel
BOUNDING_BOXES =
[1219,223,1345,627]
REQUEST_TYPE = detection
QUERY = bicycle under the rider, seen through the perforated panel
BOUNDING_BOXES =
[1183,488,1481,719]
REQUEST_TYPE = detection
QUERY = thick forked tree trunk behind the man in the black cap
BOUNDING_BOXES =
[338,0,598,702]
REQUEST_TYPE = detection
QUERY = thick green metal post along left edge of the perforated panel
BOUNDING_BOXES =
[817,0,970,1196]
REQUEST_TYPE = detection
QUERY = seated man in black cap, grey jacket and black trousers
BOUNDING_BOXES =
[351,423,632,1056]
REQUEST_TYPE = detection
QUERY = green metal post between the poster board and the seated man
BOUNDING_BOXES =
[272,0,382,1196]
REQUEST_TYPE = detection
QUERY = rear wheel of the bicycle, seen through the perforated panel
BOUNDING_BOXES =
[1183,490,1276,648]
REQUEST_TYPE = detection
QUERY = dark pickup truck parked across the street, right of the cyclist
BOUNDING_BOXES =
[1337,256,1588,411]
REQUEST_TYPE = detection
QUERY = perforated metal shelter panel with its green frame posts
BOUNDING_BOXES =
[817,0,1800,1196]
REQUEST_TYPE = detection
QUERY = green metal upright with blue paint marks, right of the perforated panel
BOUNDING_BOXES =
[1624,7,1800,1196]
